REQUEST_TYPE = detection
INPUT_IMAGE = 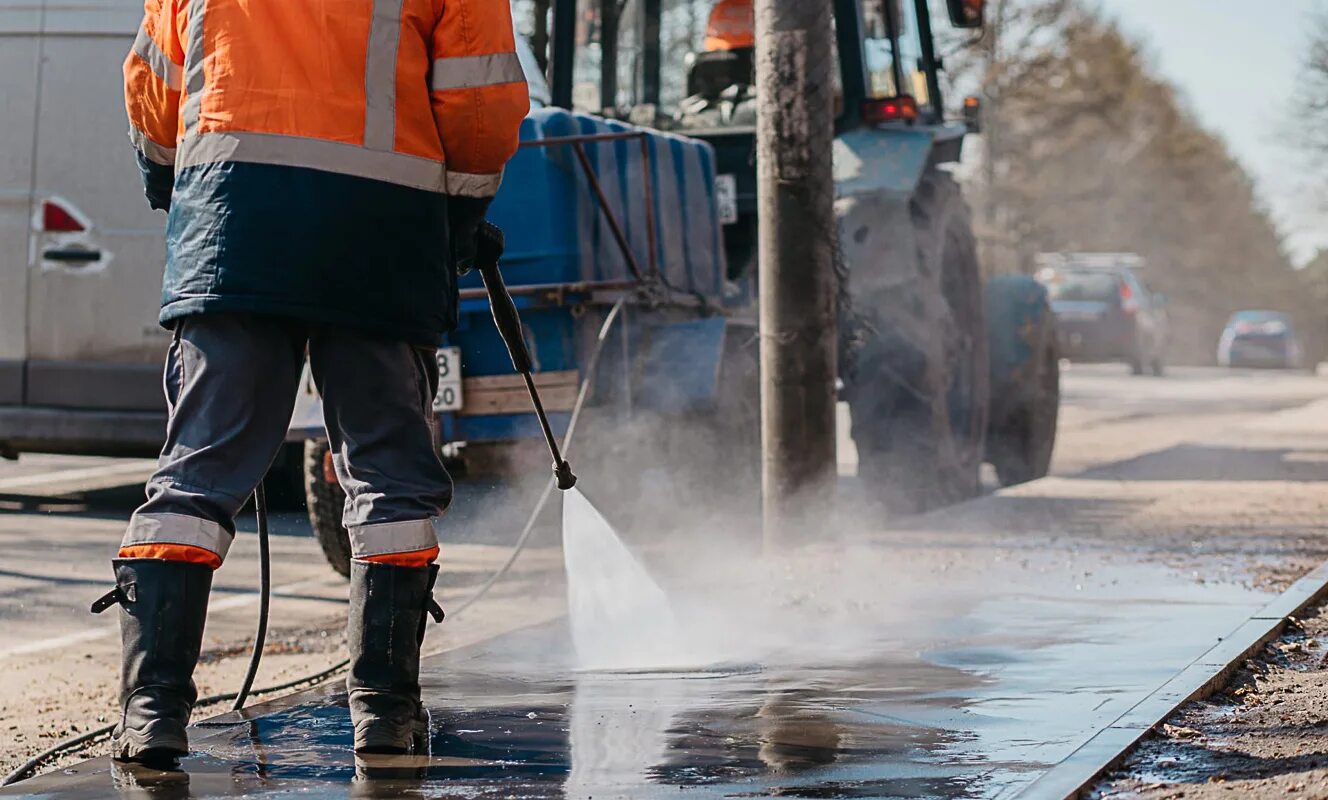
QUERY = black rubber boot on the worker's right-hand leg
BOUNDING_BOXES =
[345,561,442,755]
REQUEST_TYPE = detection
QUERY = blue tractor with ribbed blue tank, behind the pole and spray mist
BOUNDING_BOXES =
[305,0,1060,571]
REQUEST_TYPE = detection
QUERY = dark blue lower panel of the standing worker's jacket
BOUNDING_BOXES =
[161,162,457,344]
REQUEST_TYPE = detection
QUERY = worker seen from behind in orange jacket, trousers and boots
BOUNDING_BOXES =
[94,0,529,763]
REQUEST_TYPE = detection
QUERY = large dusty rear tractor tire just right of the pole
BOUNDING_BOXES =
[845,169,989,513]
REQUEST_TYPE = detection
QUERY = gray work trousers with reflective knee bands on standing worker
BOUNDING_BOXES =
[124,314,452,563]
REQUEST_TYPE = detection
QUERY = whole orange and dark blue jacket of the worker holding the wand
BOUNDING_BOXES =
[125,0,529,344]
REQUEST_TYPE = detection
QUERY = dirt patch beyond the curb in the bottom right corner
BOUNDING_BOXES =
[1090,606,1328,800]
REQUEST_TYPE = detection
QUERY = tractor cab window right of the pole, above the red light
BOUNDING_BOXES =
[862,0,927,105]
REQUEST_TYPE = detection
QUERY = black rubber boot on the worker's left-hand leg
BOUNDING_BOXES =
[92,558,212,765]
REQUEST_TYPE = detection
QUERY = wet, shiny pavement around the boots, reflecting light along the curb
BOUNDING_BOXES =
[2,547,1270,799]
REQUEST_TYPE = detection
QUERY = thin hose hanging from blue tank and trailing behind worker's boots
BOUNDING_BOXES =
[0,298,627,787]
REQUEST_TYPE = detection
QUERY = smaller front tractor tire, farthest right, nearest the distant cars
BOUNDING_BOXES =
[987,276,1061,486]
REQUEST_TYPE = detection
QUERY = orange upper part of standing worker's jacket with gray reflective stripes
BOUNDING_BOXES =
[125,0,529,197]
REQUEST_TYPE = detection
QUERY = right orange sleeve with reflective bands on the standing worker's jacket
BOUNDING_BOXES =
[430,0,530,198]
